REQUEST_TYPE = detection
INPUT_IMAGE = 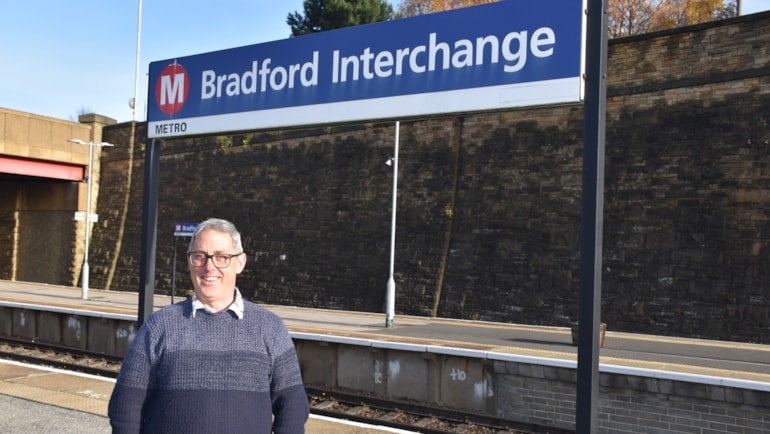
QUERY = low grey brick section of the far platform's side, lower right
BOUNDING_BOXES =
[494,361,770,434]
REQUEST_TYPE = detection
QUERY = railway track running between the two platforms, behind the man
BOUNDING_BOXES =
[0,338,574,434]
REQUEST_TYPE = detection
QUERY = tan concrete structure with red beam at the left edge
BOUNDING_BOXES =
[0,108,115,285]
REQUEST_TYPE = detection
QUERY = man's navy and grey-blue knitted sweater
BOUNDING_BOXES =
[109,300,309,434]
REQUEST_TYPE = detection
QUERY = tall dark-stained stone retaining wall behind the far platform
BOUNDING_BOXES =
[91,14,770,343]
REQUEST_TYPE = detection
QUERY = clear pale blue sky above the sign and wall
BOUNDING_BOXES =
[0,0,770,122]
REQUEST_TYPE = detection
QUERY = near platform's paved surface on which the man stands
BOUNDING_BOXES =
[0,360,414,434]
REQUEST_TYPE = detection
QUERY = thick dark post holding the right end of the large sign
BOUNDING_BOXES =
[575,0,607,434]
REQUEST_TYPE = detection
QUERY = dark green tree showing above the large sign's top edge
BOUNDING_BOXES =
[286,0,393,36]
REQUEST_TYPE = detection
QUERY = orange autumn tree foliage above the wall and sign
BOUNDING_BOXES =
[396,0,738,38]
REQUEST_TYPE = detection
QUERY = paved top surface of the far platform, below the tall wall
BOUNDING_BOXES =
[0,280,770,384]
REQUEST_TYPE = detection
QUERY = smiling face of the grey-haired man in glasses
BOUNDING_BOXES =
[188,229,246,311]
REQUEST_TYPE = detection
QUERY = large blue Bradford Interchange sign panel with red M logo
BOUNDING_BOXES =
[147,0,585,138]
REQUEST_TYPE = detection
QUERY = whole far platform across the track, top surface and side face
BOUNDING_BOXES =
[0,281,770,433]
